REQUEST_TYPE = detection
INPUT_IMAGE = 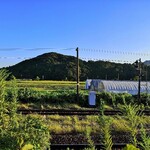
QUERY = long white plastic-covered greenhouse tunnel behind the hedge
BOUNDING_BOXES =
[86,79,150,95]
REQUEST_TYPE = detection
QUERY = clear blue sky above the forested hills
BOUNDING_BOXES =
[0,0,150,67]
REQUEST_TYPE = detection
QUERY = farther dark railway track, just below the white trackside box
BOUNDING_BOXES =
[18,109,150,116]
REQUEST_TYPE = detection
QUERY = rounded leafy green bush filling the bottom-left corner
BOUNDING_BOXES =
[0,116,50,150]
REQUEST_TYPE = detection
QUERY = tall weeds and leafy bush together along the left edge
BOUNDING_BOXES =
[0,70,50,150]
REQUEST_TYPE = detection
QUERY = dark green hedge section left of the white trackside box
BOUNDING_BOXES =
[18,88,88,106]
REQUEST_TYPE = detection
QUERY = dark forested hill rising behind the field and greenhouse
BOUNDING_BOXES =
[3,52,149,80]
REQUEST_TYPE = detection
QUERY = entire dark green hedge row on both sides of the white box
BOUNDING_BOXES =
[6,88,150,108]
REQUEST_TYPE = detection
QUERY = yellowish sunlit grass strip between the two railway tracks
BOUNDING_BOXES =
[36,115,149,134]
